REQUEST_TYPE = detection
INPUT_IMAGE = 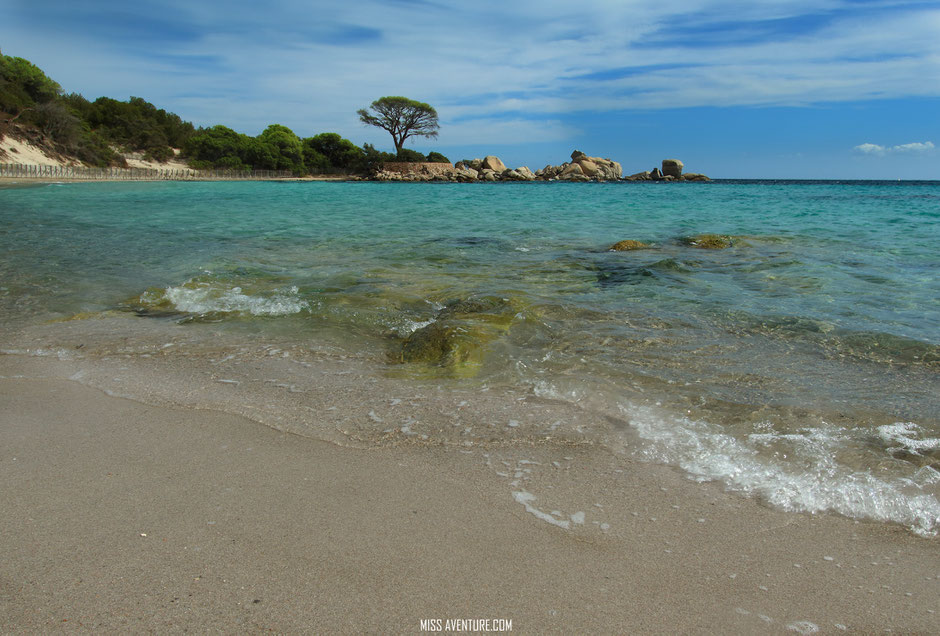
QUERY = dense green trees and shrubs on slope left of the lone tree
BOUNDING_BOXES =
[0,54,447,175]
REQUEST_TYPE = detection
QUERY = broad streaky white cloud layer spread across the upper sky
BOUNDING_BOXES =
[3,0,940,141]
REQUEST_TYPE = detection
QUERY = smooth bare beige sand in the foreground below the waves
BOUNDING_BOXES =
[0,366,940,634]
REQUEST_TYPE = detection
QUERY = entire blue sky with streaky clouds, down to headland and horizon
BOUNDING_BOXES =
[0,0,940,179]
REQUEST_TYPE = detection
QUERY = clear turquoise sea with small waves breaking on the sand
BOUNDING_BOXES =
[0,181,940,537]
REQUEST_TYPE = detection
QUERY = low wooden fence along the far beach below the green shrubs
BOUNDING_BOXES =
[0,163,293,181]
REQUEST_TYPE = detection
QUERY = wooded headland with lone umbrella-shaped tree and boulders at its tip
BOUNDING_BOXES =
[0,54,696,180]
